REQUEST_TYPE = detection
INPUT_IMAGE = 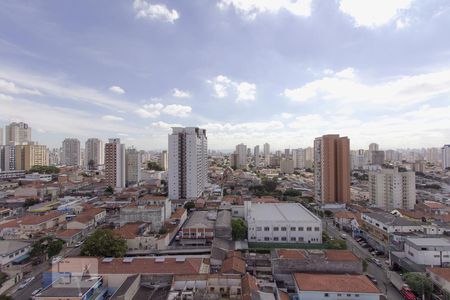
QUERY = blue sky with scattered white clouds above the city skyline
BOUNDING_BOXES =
[0,0,450,150]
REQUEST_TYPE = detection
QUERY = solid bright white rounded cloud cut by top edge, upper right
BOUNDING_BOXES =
[339,0,414,28]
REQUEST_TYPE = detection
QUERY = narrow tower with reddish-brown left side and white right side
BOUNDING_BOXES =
[105,139,126,189]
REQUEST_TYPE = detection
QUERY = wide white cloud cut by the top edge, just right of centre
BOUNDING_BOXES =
[217,0,312,20]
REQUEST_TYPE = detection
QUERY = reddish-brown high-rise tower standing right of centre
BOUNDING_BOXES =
[314,134,350,204]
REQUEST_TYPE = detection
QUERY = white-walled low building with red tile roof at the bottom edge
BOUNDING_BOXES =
[293,273,382,300]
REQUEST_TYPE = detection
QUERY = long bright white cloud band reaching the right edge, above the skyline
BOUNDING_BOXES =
[282,68,450,108]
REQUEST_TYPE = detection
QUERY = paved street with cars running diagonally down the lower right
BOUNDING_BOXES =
[323,220,403,300]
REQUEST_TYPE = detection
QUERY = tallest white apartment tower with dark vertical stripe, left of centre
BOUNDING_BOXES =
[168,127,208,199]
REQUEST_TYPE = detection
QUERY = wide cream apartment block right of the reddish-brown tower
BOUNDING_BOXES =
[369,168,416,211]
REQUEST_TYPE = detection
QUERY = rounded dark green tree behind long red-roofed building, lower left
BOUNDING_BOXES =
[81,229,127,257]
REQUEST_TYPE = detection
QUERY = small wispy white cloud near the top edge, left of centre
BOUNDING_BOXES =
[133,0,180,23]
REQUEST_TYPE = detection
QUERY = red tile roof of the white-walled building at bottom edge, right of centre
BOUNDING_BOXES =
[294,273,380,294]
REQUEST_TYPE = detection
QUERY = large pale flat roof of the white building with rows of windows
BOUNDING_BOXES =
[250,203,320,222]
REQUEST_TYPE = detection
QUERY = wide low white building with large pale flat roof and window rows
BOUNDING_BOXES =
[245,201,322,244]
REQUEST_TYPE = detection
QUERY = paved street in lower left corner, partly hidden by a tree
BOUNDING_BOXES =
[9,247,80,300]
